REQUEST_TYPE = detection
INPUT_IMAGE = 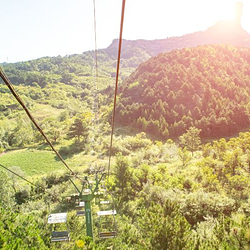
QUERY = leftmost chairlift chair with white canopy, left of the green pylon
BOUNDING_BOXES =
[48,213,70,242]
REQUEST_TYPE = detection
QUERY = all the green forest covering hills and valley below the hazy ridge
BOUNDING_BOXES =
[0,45,250,250]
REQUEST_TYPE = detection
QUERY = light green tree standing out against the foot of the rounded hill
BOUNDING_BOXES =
[179,127,201,155]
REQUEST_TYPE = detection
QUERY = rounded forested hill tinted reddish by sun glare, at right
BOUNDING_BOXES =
[116,45,250,138]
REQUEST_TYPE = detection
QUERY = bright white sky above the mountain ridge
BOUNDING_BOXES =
[0,0,250,63]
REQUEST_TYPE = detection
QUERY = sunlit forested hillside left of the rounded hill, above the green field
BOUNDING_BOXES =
[0,47,141,151]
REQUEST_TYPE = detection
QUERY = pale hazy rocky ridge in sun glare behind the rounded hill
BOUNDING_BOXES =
[106,21,250,58]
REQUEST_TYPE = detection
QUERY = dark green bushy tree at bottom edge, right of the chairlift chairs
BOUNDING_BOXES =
[138,200,191,250]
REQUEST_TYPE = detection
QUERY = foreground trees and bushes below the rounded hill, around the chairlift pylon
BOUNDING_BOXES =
[0,130,250,250]
